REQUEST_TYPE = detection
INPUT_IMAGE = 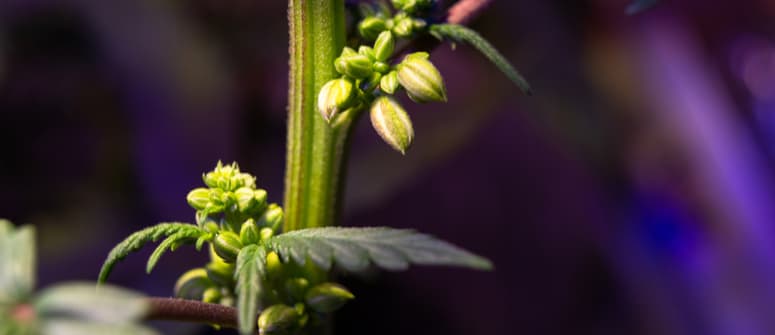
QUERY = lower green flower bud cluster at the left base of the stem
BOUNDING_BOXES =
[175,162,358,334]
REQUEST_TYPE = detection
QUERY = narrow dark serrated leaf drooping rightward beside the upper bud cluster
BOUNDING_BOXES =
[430,24,533,95]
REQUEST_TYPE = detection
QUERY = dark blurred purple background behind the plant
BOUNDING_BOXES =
[0,0,775,335]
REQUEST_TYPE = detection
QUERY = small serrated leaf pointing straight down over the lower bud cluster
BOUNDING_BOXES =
[234,244,266,334]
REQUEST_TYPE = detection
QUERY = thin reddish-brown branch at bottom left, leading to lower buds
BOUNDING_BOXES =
[146,297,237,328]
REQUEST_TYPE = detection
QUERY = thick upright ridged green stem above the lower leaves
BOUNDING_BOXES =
[283,0,352,231]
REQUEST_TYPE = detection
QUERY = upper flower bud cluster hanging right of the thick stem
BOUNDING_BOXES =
[317,0,447,154]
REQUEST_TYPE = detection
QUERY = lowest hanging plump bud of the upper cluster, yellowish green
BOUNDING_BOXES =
[371,96,414,154]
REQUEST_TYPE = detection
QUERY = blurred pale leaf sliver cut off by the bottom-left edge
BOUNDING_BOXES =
[40,319,159,335]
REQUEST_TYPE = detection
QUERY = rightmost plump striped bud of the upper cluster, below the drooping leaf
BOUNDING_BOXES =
[397,52,447,103]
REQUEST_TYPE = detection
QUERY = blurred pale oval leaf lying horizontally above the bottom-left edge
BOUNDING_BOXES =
[34,282,150,324]
